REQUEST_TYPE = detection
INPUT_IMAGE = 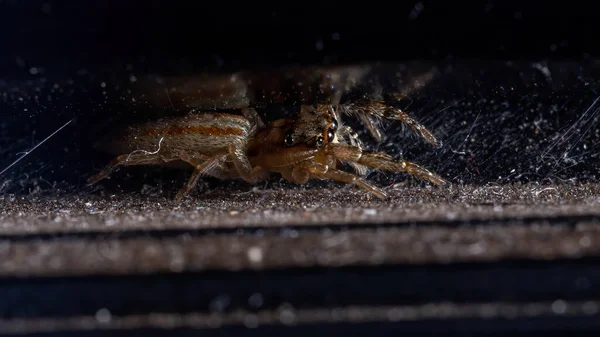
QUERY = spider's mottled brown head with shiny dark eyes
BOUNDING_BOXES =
[283,104,338,147]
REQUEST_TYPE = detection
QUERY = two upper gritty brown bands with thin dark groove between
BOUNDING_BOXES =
[0,184,600,276]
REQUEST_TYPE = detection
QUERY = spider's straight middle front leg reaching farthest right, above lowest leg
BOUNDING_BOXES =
[326,144,450,186]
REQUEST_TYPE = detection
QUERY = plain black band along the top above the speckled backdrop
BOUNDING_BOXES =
[0,0,599,72]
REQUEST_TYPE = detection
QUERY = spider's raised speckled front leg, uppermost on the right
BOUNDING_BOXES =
[339,101,442,147]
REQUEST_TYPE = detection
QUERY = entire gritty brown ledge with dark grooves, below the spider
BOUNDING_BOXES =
[0,184,600,333]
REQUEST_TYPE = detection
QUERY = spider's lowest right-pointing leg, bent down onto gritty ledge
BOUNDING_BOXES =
[288,161,387,199]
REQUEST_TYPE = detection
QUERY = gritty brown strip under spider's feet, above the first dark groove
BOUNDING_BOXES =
[0,183,600,236]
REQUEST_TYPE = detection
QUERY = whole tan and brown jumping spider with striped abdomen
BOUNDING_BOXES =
[88,102,447,200]
